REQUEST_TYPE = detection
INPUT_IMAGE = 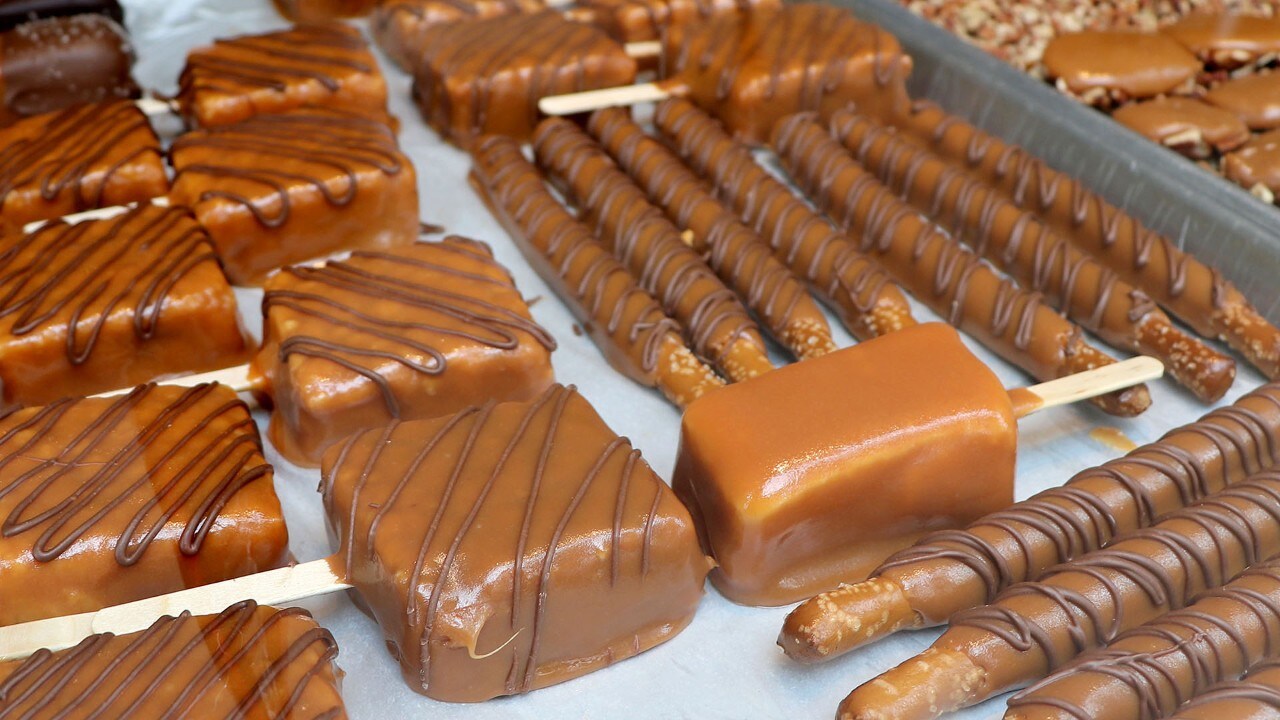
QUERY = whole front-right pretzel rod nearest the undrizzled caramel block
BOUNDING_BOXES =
[778,383,1280,662]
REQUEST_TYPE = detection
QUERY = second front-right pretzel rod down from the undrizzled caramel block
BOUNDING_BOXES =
[838,471,1280,720]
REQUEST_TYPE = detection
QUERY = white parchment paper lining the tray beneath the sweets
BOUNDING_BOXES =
[117,0,1262,720]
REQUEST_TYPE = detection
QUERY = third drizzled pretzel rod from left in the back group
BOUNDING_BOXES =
[586,108,836,360]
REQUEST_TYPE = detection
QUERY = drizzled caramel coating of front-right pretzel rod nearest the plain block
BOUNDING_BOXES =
[873,386,1280,609]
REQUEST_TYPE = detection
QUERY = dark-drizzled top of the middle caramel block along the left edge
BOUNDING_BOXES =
[0,205,218,365]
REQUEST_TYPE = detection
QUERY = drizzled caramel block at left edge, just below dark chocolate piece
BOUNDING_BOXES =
[0,101,169,231]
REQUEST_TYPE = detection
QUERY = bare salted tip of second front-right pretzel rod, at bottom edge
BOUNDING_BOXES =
[836,648,986,720]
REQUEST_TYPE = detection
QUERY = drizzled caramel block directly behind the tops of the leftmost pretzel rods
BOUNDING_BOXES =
[413,10,636,147]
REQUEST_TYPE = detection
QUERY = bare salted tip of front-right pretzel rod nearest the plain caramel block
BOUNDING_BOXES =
[778,578,920,665]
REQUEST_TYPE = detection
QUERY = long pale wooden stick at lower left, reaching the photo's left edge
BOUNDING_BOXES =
[0,560,351,661]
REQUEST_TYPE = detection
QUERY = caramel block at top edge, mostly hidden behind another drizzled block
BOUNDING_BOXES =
[371,0,547,72]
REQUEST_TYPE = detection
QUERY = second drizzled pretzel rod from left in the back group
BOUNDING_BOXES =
[534,118,773,380]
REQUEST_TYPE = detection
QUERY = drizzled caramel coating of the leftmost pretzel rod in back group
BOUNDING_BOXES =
[474,136,682,384]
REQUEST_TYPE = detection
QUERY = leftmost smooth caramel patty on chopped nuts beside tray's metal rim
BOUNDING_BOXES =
[1043,29,1201,108]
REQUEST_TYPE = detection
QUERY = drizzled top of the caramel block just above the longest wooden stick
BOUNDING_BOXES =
[0,384,271,566]
